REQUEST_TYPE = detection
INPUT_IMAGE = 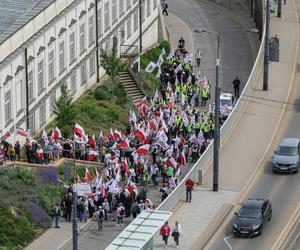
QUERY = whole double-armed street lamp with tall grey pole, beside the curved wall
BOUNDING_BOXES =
[194,28,259,191]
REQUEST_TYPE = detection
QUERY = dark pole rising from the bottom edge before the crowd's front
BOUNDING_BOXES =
[72,152,78,250]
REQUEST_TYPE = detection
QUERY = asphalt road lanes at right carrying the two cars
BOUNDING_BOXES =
[203,1,300,250]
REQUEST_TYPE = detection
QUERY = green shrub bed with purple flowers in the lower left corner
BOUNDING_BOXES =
[0,167,65,249]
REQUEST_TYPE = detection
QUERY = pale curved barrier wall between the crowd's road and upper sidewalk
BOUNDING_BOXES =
[157,8,265,210]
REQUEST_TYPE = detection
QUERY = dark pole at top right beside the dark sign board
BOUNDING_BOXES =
[263,0,270,90]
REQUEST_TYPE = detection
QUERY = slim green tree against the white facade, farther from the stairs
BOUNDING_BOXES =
[53,83,76,136]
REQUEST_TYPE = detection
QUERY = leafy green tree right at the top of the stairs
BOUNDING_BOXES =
[100,39,126,88]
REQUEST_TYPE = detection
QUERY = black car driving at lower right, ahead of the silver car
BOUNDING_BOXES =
[232,199,272,237]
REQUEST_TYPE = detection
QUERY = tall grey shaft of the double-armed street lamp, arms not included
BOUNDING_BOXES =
[213,33,220,192]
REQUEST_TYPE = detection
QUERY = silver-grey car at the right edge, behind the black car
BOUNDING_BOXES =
[272,138,300,173]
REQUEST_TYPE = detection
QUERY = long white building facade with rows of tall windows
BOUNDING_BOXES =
[0,0,159,134]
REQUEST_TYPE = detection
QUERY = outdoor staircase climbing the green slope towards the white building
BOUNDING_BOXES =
[119,70,145,106]
